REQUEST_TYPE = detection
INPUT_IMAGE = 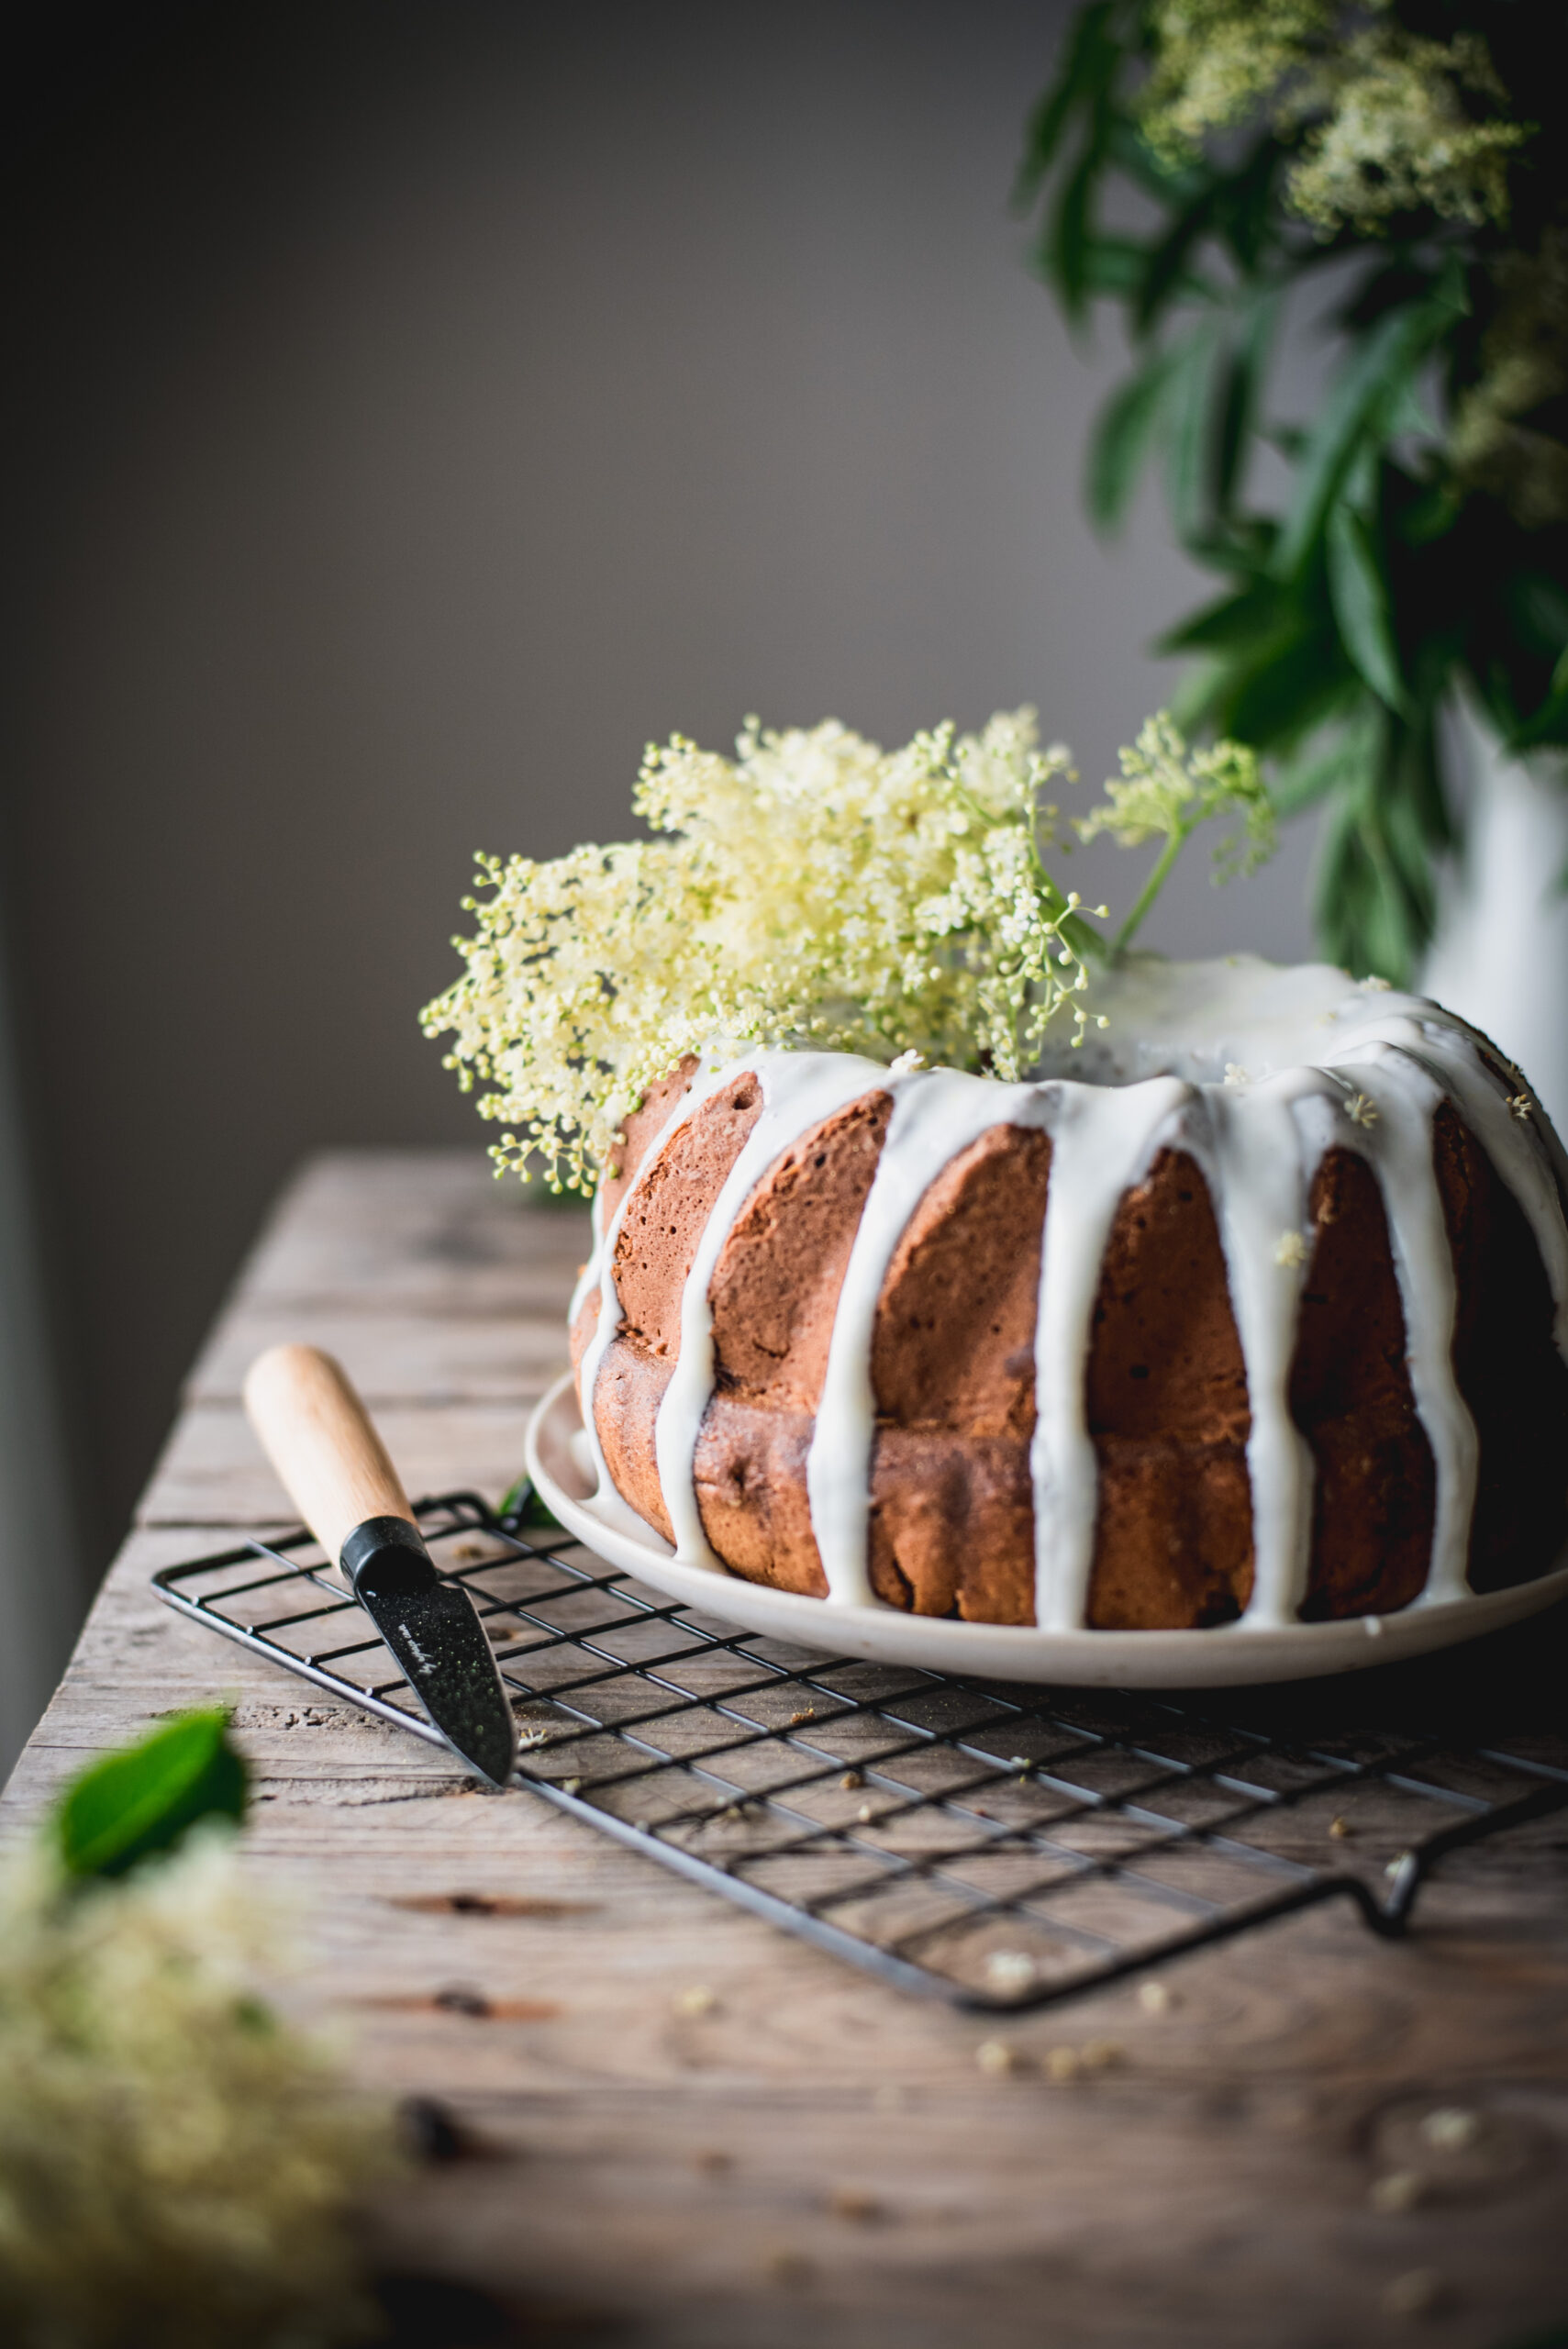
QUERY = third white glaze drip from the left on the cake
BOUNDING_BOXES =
[806,1069,1044,1607]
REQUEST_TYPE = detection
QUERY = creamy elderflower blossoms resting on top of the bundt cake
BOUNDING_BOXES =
[420,709,1268,1191]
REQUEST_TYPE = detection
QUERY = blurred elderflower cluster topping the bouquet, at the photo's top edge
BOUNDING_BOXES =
[1143,0,1533,235]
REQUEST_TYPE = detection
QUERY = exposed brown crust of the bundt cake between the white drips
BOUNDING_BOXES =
[575,1071,1568,1631]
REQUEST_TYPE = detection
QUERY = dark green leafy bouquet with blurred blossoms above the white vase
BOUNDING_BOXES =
[1018,0,1568,982]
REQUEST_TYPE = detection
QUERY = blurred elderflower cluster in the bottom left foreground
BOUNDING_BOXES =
[0,1825,390,2349]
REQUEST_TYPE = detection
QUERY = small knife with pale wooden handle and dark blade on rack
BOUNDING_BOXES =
[244,1346,517,1786]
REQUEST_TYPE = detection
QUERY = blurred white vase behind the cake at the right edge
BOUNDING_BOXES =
[1418,707,1568,1134]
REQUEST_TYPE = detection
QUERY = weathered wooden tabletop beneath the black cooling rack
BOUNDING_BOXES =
[5,1151,1568,2349]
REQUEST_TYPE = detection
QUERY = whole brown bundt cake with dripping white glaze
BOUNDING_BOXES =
[573,956,1568,1631]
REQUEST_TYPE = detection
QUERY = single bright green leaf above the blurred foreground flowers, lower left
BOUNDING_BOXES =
[54,1708,247,1876]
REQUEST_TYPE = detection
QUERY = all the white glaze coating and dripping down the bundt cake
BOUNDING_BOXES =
[584,956,1568,1631]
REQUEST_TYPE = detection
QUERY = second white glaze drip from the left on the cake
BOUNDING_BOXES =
[652,1052,899,1572]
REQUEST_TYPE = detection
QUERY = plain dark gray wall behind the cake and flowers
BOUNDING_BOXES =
[0,0,1307,1766]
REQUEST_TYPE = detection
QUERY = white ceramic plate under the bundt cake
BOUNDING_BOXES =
[526,1376,1568,1689]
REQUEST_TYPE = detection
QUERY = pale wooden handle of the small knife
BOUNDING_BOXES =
[244,1346,416,1567]
